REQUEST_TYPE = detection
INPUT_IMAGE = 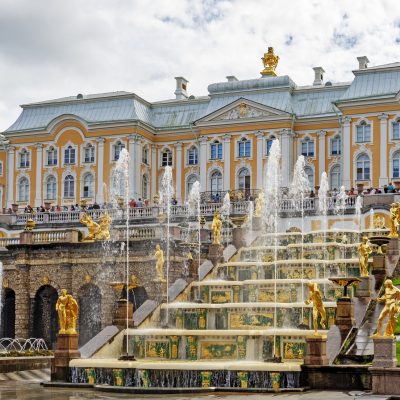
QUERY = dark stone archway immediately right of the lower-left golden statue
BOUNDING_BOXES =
[78,283,102,346]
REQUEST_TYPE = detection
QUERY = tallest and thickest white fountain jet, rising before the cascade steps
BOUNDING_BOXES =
[263,139,281,356]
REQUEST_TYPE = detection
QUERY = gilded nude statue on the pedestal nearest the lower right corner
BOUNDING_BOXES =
[371,279,400,338]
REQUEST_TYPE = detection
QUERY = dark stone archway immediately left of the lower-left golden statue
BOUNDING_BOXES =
[32,285,58,349]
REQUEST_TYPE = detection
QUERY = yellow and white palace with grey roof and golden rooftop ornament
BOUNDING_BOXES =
[0,48,400,208]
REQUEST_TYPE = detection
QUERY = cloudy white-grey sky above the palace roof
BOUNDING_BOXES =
[0,0,400,132]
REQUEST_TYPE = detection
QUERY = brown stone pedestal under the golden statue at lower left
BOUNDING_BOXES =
[51,334,81,382]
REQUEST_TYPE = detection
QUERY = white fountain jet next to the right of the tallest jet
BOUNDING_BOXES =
[290,156,310,323]
